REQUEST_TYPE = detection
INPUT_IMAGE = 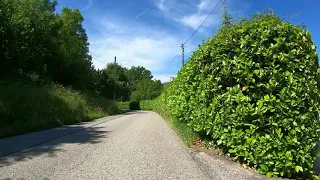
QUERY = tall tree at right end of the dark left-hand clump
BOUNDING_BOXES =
[50,8,93,89]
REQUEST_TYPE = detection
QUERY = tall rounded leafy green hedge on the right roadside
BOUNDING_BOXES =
[166,14,320,177]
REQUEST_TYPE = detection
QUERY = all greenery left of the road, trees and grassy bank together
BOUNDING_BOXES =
[0,0,162,137]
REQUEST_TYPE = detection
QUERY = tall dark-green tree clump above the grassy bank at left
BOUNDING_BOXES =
[0,0,92,89]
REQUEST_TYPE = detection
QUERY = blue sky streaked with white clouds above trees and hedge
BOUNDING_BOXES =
[57,0,320,82]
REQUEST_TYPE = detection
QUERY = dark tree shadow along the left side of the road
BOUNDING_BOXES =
[0,111,148,168]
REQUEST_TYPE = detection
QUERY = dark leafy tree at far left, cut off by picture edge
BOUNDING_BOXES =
[0,0,58,77]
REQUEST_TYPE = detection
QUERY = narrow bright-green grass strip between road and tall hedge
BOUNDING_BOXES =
[141,100,198,147]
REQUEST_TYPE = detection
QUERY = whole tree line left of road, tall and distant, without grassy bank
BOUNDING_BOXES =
[0,0,161,101]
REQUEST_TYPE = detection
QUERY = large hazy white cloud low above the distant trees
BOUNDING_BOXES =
[90,16,181,74]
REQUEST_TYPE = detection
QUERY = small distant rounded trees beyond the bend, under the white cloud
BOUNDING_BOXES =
[92,63,162,101]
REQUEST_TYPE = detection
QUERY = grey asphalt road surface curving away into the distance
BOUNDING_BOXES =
[0,111,207,180]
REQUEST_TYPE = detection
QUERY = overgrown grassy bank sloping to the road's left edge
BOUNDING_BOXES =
[0,82,120,138]
